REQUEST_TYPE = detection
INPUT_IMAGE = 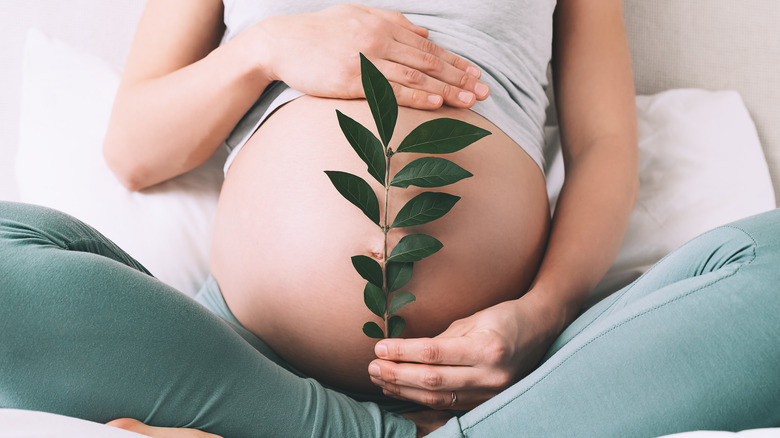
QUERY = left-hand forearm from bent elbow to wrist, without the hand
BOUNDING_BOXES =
[104,33,270,190]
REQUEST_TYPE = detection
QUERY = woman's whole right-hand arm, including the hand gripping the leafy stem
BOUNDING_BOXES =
[369,0,638,409]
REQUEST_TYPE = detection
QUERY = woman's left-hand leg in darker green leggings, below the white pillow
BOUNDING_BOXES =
[0,203,414,437]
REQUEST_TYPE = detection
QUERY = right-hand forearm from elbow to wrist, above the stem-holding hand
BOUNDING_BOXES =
[527,144,639,330]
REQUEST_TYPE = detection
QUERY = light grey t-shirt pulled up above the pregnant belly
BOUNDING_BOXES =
[223,0,556,168]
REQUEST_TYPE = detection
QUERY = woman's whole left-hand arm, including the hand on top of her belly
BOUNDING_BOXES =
[104,0,487,190]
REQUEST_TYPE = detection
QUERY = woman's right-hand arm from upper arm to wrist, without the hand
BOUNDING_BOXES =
[529,0,639,330]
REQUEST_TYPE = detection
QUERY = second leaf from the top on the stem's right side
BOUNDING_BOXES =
[390,157,474,189]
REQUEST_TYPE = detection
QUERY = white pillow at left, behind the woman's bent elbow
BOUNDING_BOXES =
[16,29,225,295]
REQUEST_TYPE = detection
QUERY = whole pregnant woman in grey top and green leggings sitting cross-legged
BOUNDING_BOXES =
[0,0,780,437]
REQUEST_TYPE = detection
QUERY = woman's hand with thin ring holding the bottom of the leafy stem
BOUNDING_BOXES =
[368,292,563,410]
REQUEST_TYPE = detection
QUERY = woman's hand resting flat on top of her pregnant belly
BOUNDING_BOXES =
[247,5,489,109]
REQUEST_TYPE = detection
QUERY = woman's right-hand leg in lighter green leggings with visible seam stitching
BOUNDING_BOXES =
[432,211,780,437]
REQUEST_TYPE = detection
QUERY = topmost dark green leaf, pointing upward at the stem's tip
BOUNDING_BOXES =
[360,53,398,148]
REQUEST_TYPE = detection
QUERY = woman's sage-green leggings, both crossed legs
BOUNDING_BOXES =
[0,202,780,438]
